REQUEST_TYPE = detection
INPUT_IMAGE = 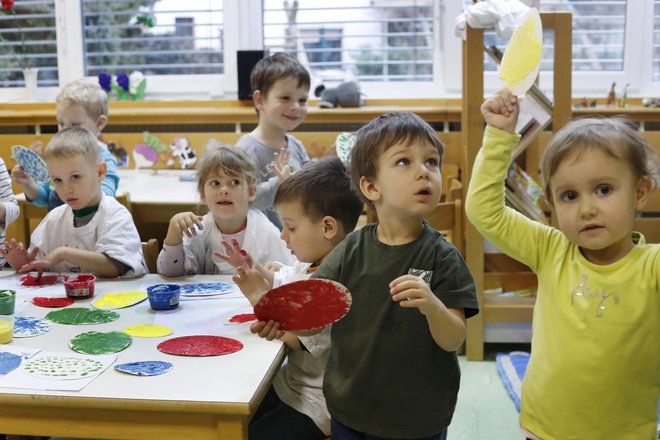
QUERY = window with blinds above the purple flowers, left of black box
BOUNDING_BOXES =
[82,0,224,76]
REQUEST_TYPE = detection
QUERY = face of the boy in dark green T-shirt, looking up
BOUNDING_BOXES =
[360,141,442,217]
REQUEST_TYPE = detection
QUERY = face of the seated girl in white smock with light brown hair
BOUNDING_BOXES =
[201,169,257,233]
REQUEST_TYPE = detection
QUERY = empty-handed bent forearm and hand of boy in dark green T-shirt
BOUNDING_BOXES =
[390,275,467,351]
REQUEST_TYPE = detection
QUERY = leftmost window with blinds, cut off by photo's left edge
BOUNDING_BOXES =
[0,0,58,87]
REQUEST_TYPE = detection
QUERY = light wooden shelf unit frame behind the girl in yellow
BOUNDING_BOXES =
[461,12,572,360]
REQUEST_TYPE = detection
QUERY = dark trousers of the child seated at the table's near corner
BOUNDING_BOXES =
[248,385,325,440]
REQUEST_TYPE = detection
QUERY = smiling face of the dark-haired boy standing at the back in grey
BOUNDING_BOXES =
[254,77,309,132]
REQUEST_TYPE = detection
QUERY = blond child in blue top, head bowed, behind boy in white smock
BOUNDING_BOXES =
[11,79,119,211]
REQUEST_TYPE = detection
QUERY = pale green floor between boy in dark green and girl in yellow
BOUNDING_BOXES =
[448,344,529,440]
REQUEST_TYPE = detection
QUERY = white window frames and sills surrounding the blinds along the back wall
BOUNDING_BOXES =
[0,0,660,102]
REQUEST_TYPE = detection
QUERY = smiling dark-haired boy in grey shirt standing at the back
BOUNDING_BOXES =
[236,53,310,230]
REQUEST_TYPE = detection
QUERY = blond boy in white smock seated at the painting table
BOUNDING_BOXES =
[2,128,146,277]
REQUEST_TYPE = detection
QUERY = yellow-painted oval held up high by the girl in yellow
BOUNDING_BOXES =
[500,8,543,96]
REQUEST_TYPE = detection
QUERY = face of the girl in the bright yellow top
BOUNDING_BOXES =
[550,148,646,264]
